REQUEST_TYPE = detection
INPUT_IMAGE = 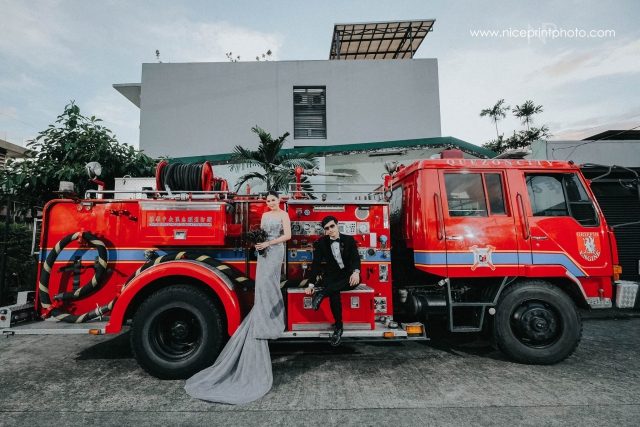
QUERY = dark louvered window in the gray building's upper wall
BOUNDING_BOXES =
[293,86,327,139]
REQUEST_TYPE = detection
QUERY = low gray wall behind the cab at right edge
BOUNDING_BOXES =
[529,140,640,168]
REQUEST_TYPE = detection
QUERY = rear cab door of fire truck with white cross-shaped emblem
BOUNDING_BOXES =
[440,170,520,277]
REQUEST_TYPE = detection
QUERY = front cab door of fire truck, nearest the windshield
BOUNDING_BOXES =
[524,172,612,284]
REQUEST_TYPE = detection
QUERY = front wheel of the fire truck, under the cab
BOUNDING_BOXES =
[494,280,582,365]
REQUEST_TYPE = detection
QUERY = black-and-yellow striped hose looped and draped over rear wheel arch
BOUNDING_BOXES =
[38,231,254,323]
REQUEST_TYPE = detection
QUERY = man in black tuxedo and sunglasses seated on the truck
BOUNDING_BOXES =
[305,216,360,346]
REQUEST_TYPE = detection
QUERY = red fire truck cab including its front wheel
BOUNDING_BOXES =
[390,158,635,364]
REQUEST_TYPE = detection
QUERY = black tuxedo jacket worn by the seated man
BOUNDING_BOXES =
[309,233,360,283]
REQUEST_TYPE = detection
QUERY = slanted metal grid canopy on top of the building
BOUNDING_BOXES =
[329,19,435,59]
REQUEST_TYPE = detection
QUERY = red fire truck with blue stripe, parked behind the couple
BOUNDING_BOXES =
[0,153,638,378]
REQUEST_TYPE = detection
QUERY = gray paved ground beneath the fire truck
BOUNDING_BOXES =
[0,318,640,426]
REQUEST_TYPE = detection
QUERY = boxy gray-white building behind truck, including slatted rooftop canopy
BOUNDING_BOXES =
[114,20,493,191]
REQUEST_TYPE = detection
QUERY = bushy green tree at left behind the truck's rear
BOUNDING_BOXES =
[0,101,155,205]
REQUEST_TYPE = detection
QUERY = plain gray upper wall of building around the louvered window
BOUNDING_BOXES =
[140,59,441,157]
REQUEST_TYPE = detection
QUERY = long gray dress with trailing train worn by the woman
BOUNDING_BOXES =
[185,215,284,404]
